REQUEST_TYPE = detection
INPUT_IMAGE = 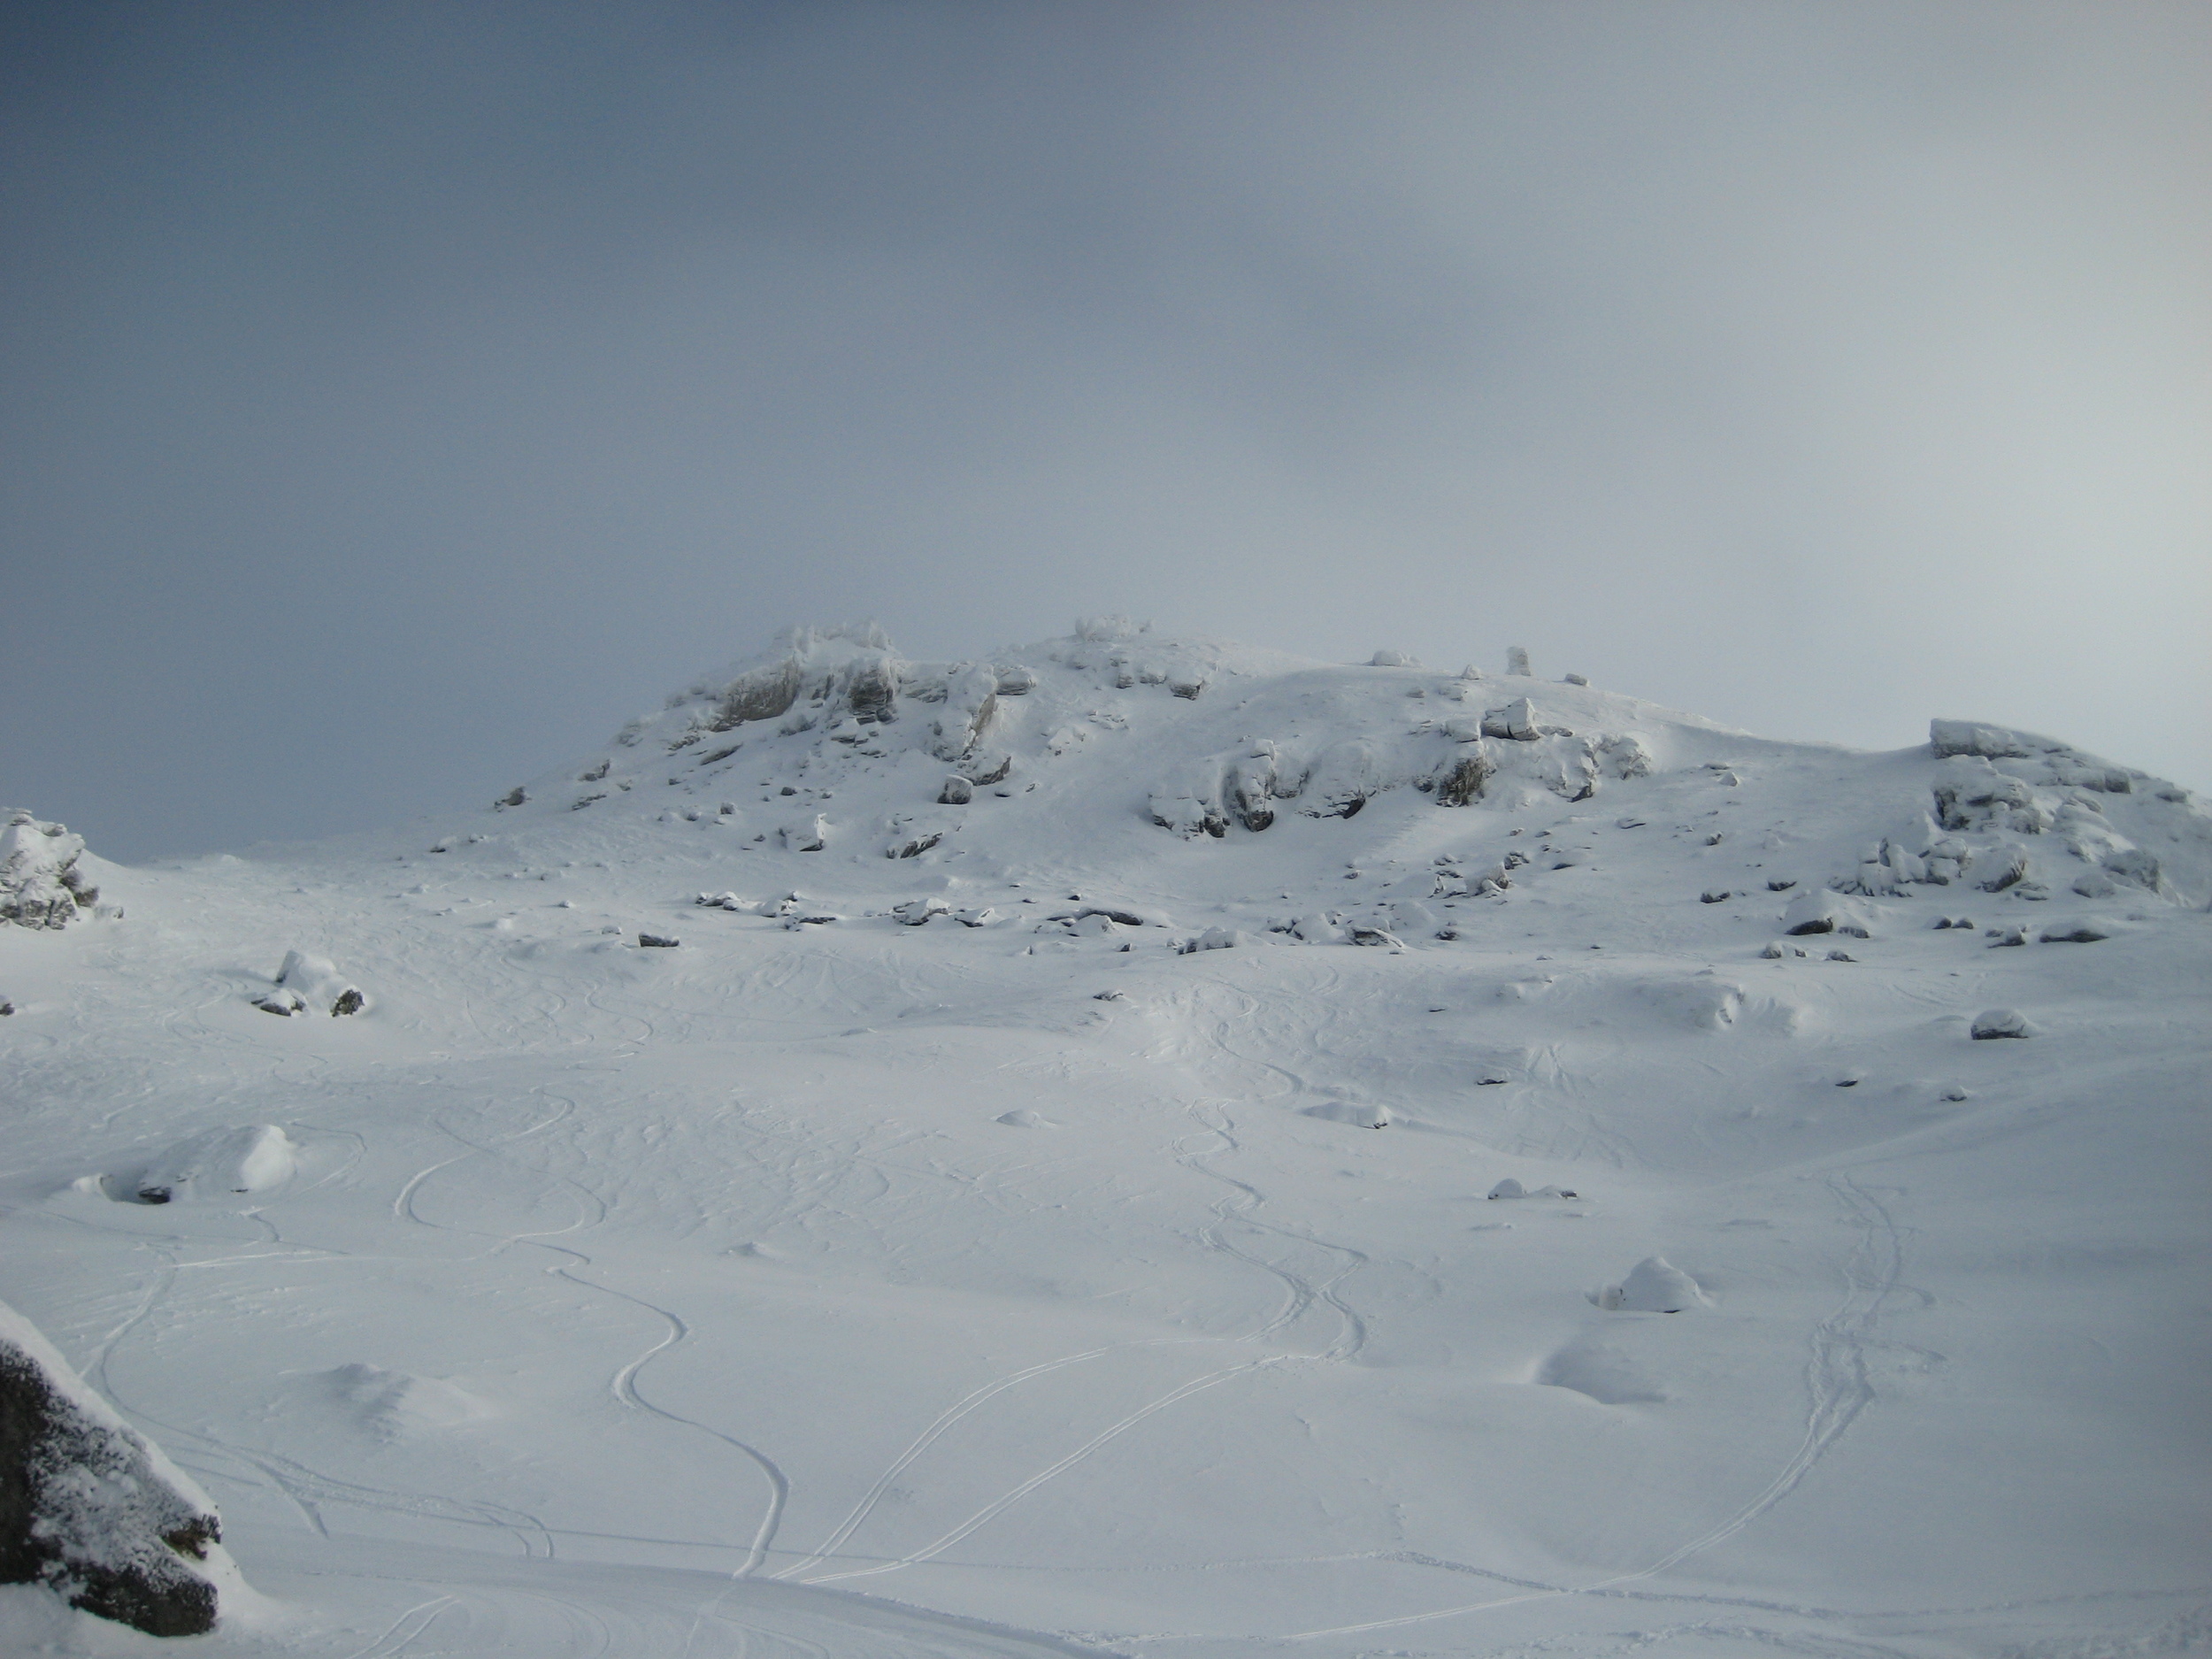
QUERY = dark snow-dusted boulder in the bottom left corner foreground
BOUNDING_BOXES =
[0,1303,237,1637]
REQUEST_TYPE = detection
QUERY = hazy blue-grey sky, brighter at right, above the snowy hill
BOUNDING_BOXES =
[0,0,2212,858]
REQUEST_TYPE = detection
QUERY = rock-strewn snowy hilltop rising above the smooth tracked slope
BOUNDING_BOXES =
[462,618,2212,941]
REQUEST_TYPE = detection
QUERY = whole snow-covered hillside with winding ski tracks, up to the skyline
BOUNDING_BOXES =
[0,619,2212,1659]
